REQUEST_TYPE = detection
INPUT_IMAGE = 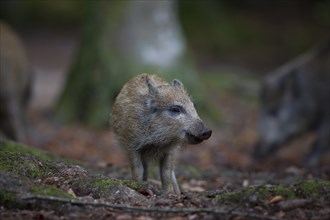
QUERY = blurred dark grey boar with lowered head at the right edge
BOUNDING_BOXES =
[254,39,330,166]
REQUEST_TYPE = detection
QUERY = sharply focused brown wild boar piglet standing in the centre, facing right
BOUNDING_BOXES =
[111,74,212,194]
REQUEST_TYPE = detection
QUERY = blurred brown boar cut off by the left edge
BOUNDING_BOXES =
[0,21,31,141]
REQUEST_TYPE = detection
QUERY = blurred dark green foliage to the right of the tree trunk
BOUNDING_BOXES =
[179,0,330,72]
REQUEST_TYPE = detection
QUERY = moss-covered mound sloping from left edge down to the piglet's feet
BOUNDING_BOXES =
[0,140,159,212]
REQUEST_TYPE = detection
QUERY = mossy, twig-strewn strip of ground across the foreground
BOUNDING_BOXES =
[0,140,330,218]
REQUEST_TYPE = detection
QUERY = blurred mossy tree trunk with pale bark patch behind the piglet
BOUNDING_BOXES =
[57,1,200,126]
